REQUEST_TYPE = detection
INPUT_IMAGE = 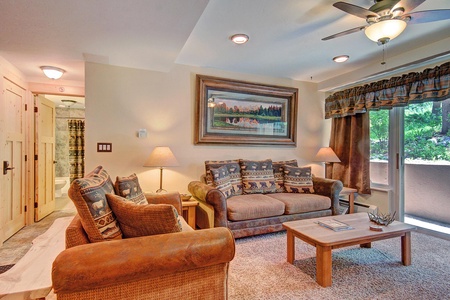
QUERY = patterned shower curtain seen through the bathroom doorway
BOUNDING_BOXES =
[68,120,84,183]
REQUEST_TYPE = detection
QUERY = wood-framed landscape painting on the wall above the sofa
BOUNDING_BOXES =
[194,75,298,146]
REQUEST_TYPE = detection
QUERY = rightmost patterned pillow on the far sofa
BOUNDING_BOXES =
[283,165,314,194]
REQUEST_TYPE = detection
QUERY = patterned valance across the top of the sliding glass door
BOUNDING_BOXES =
[325,62,450,119]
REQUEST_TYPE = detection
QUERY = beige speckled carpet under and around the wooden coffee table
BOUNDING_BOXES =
[228,232,450,300]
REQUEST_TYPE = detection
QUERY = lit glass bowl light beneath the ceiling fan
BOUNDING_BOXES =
[364,19,406,44]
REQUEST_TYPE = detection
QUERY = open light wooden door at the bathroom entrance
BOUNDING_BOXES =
[34,96,55,221]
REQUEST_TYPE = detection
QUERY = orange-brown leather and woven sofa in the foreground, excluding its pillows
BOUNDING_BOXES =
[52,168,235,300]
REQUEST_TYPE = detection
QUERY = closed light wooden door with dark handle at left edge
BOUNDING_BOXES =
[0,77,26,244]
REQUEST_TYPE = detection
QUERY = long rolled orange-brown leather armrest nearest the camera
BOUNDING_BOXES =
[52,228,235,294]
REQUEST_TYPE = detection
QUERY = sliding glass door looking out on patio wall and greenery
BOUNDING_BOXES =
[370,99,450,227]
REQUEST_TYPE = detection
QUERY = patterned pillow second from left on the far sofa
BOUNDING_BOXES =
[239,159,276,194]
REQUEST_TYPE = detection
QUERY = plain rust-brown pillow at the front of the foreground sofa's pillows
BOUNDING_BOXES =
[106,194,182,238]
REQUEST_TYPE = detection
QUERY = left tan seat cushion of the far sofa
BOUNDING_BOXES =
[227,194,285,221]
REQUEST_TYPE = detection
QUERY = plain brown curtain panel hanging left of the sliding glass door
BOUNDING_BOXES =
[326,114,370,194]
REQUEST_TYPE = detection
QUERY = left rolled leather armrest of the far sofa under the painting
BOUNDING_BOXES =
[188,181,228,227]
